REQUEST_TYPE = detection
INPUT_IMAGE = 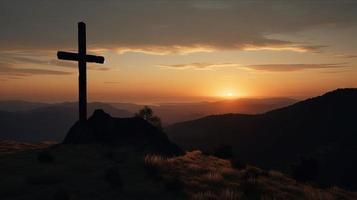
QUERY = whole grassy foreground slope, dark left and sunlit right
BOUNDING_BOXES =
[0,145,357,200]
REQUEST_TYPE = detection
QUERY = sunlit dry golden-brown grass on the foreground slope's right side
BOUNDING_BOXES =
[145,151,357,200]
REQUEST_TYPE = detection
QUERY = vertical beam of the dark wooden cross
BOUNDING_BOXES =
[78,22,87,122]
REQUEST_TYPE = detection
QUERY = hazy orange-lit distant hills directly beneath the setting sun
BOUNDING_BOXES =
[110,98,296,125]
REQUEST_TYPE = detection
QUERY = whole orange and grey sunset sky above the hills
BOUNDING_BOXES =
[0,0,357,103]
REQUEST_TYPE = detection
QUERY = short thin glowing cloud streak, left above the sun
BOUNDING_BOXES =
[158,62,239,70]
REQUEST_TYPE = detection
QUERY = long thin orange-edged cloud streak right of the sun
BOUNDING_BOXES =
[246,63,349,72]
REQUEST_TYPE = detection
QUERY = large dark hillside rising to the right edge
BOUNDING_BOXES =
[166,89,357,189]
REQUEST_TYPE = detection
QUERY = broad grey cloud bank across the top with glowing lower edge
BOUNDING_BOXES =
[0,0,357,55]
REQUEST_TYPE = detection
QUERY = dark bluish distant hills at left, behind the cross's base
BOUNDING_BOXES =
[0,103,133,142]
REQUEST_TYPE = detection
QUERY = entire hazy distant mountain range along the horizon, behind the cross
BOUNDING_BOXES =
[0,98,295,142]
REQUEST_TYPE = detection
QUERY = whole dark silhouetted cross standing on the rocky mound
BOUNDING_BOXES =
[57,22,104,123]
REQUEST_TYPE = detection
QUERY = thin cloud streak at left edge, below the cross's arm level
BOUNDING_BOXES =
[0,63,72,78]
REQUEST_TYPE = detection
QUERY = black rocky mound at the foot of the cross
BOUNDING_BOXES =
[63,110,183,156]
